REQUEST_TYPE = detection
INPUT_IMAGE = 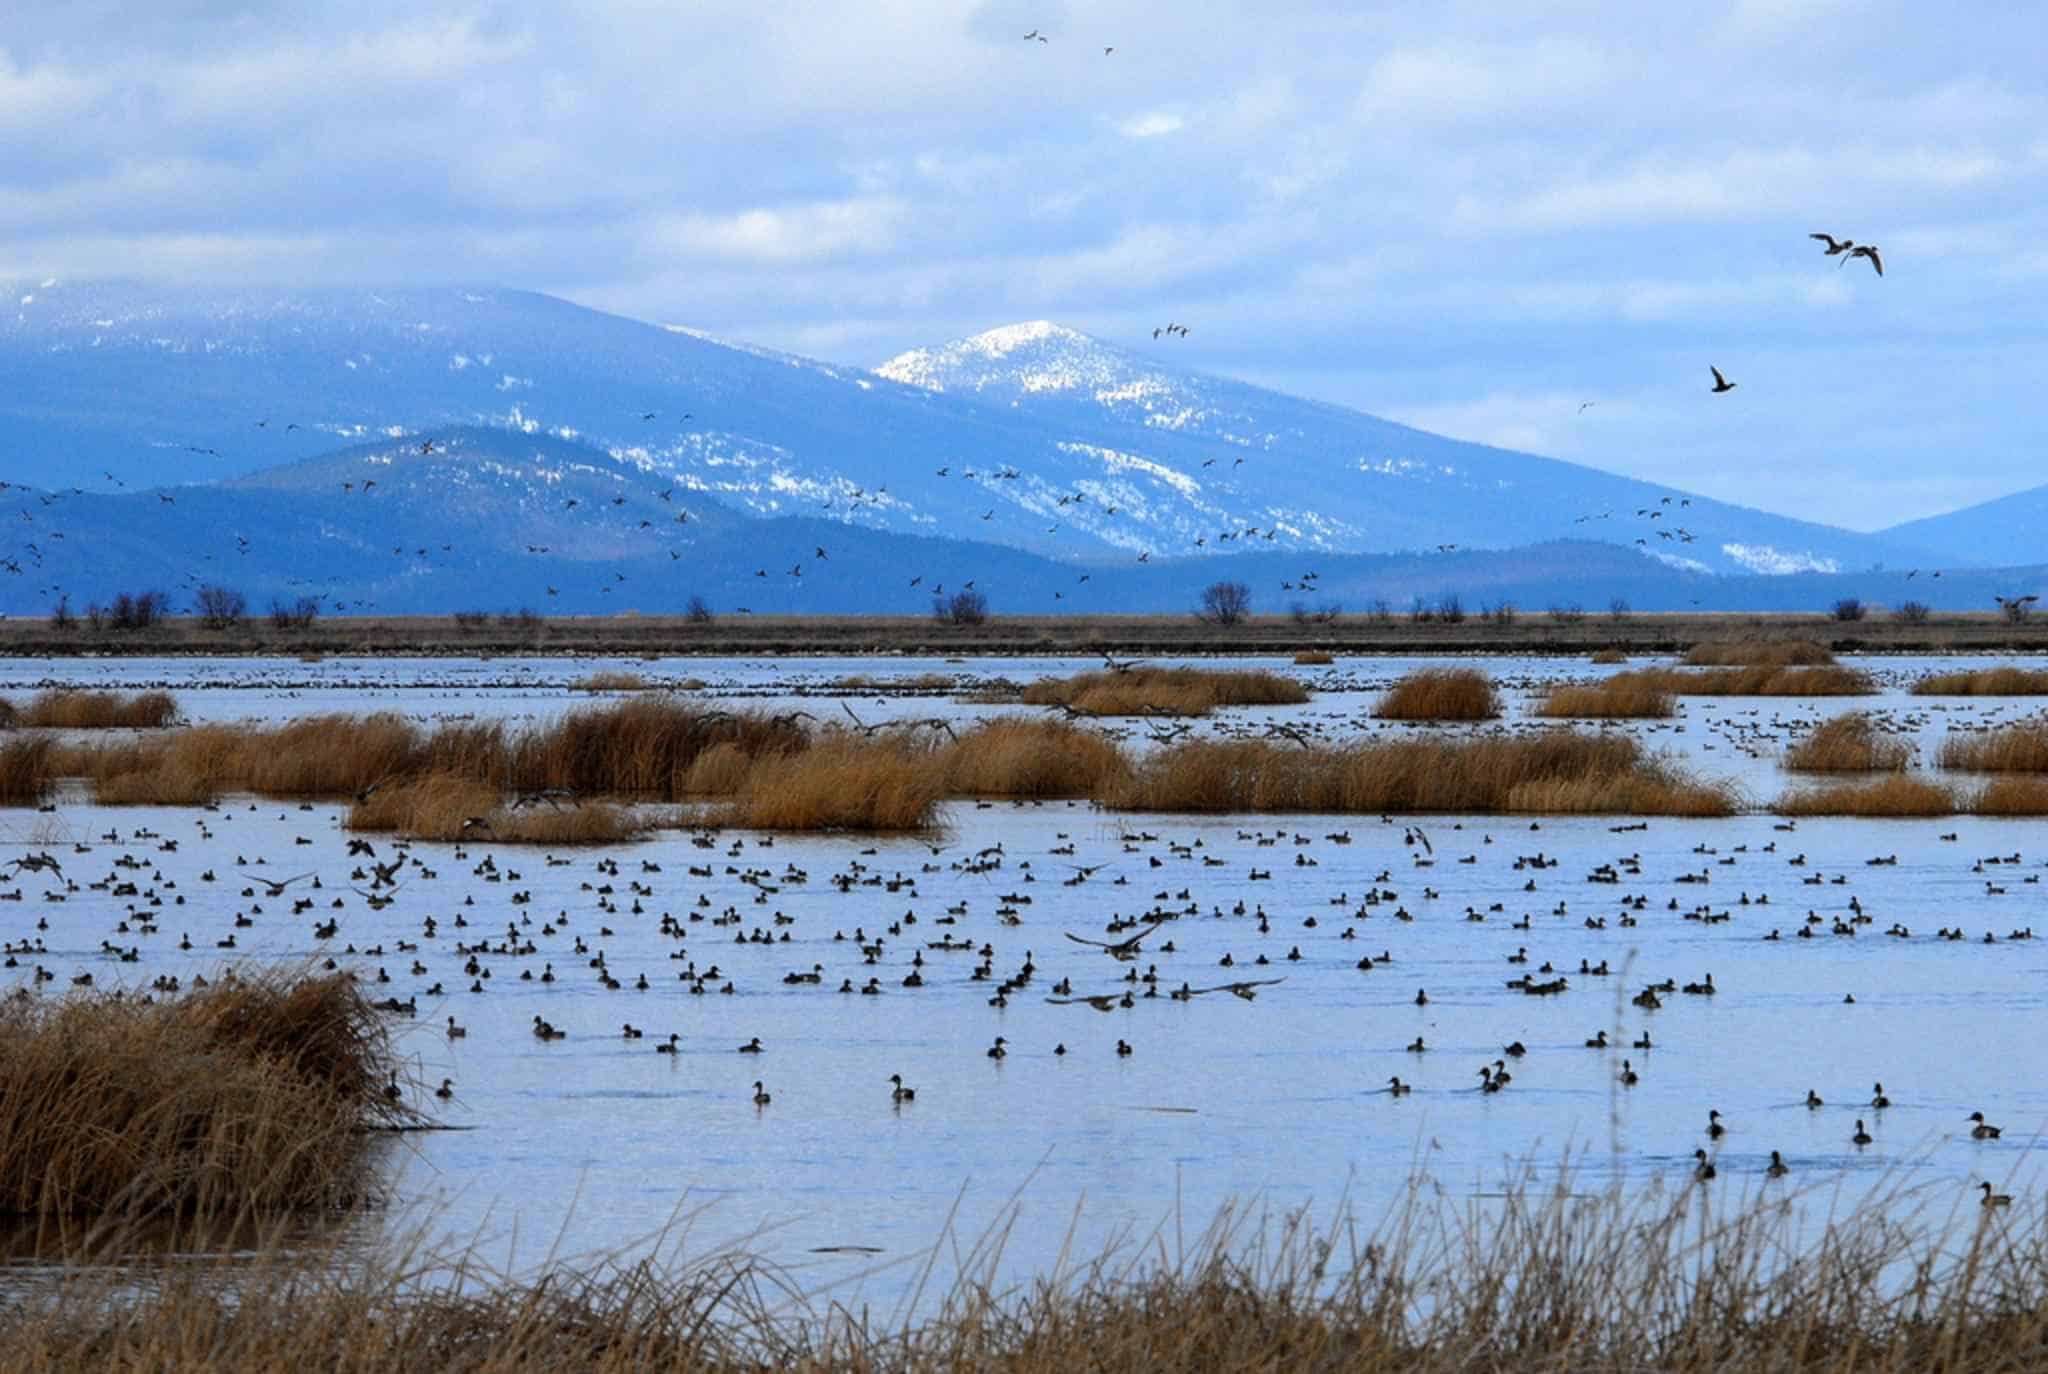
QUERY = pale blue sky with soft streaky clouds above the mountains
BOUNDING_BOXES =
[0,0,2048,530]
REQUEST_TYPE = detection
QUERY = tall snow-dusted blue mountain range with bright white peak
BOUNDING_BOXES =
[0,283,1935,575]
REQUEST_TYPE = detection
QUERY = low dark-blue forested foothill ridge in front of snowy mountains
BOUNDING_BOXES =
[0,426,2048,616]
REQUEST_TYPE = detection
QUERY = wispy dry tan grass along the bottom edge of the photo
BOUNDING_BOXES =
[0,1179,2048,1374]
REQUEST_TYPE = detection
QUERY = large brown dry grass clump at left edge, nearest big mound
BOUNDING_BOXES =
[0,973,410,1218]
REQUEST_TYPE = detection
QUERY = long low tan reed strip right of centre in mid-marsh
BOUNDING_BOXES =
[1100,731,1741,817]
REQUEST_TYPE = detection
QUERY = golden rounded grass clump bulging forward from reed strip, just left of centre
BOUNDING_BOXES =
[717,735,944,831]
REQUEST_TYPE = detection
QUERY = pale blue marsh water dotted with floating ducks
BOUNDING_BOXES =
[0,657,2048,1302]
